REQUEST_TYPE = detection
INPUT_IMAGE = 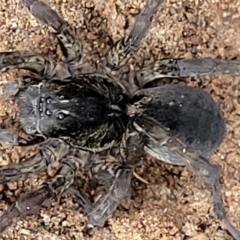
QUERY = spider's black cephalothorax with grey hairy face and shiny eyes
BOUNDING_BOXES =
[8,74,129,148]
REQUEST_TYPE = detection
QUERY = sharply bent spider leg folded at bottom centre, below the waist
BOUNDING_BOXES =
[69,125,145,227]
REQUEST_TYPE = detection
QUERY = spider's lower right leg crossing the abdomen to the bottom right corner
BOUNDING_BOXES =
[135,117,240,239]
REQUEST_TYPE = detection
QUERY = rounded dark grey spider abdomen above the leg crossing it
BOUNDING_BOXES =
[141,84,225,159]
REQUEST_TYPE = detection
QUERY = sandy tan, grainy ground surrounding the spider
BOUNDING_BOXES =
[0,0,240,240]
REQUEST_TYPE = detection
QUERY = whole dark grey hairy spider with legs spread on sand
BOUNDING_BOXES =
[0,0,240,239]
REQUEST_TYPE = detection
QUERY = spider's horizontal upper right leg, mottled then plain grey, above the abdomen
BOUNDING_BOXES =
[134,58,240,88]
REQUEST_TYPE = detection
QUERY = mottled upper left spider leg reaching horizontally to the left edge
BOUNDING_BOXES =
[0,51,71,79]
